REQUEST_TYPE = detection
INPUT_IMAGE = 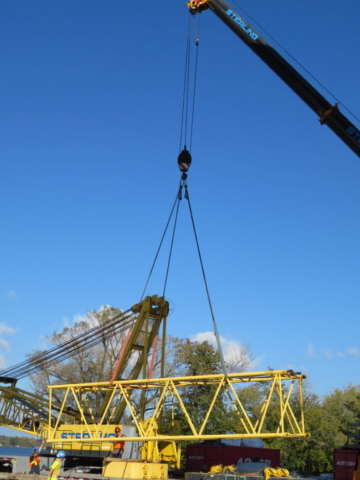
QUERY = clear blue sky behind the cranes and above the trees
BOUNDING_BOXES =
[0,0,360,436]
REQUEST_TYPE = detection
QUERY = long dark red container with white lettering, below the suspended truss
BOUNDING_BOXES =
[185,444,280,472]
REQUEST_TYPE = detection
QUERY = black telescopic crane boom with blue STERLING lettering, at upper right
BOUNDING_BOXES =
[188,0,360,157]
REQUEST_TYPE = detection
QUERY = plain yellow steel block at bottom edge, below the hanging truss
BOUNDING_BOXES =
[102,458,169,479]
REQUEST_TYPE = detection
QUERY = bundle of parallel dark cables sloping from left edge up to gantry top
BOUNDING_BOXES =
[0,309,134,378]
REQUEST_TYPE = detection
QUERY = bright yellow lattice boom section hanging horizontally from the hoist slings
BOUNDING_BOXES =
[48,370,309,443]
